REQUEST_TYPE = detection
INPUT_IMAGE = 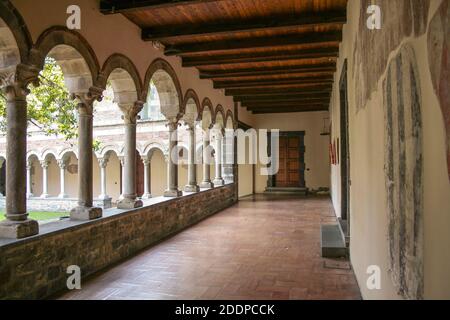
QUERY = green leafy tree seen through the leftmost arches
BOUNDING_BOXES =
[0,57,77,140]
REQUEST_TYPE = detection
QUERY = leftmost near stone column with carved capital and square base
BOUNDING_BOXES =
[0,65,39,239]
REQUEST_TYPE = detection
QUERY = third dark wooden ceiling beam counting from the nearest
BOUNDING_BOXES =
[164,31,342,56]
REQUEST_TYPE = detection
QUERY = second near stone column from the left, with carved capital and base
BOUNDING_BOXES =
[70,88,102,220]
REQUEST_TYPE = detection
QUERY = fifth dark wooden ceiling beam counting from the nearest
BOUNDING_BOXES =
[200,62,336,79]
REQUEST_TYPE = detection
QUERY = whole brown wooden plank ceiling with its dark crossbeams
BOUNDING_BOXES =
[100,0,347,113]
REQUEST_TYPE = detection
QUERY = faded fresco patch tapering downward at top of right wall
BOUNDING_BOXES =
[353,0,430,110]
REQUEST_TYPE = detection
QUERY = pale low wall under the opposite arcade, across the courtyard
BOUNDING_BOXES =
[0,197,112,212]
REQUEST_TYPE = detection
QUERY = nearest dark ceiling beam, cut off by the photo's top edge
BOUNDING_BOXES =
[100,0,224,14]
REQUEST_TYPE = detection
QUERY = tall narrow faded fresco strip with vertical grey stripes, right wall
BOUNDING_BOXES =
[384,46,423,299]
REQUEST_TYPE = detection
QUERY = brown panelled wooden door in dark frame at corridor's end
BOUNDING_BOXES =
[276,136,302,188]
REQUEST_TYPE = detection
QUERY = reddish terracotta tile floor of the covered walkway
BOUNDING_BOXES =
[60,196,360,299]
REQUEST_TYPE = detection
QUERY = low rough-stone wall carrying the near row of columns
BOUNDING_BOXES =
[0,184,237,299]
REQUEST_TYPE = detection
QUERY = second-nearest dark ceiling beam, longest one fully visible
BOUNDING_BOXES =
[142,10,347,42]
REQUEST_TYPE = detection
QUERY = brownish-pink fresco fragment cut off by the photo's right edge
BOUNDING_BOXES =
[428,1,450,179]
